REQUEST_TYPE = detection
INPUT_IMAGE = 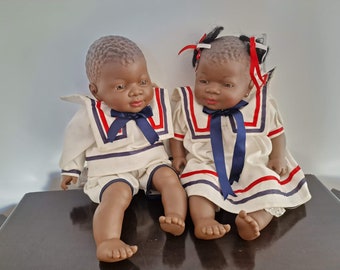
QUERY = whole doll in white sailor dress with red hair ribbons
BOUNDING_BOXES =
[170,27,311,240]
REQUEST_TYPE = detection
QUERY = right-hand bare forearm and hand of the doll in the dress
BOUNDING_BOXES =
[268,133,287,175]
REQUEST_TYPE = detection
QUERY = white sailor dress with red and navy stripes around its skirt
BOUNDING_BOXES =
[173,78,311,214]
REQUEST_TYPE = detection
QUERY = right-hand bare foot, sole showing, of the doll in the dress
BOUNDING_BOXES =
[235,210,260,240]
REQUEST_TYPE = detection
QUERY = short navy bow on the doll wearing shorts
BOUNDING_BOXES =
[107,106,159,144]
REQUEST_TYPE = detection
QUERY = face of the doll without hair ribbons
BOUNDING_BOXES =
[89,56,153,113]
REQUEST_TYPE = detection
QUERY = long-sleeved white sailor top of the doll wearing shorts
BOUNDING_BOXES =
[60,88,173,201]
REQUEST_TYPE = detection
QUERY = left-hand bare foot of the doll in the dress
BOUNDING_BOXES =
[195,219,230,240]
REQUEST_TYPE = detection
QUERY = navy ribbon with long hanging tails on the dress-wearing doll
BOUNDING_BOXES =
[203,100,248,199]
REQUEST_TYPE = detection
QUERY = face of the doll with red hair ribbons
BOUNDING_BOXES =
[194,57,253,110]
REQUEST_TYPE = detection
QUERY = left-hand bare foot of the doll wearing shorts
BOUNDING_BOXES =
[97,238,138,262]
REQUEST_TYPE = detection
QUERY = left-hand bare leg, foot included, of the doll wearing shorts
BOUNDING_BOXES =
[93,182,137,262]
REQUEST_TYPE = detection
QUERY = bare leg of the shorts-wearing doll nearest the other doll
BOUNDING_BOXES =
[152,166,187,235]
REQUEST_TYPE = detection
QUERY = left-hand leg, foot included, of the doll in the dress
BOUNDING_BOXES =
[189,196,230,240]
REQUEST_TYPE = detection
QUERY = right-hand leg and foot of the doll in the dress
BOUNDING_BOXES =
[235,210,273,240]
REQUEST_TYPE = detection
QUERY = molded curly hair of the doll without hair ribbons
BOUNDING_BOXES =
[85,36,144,83]
